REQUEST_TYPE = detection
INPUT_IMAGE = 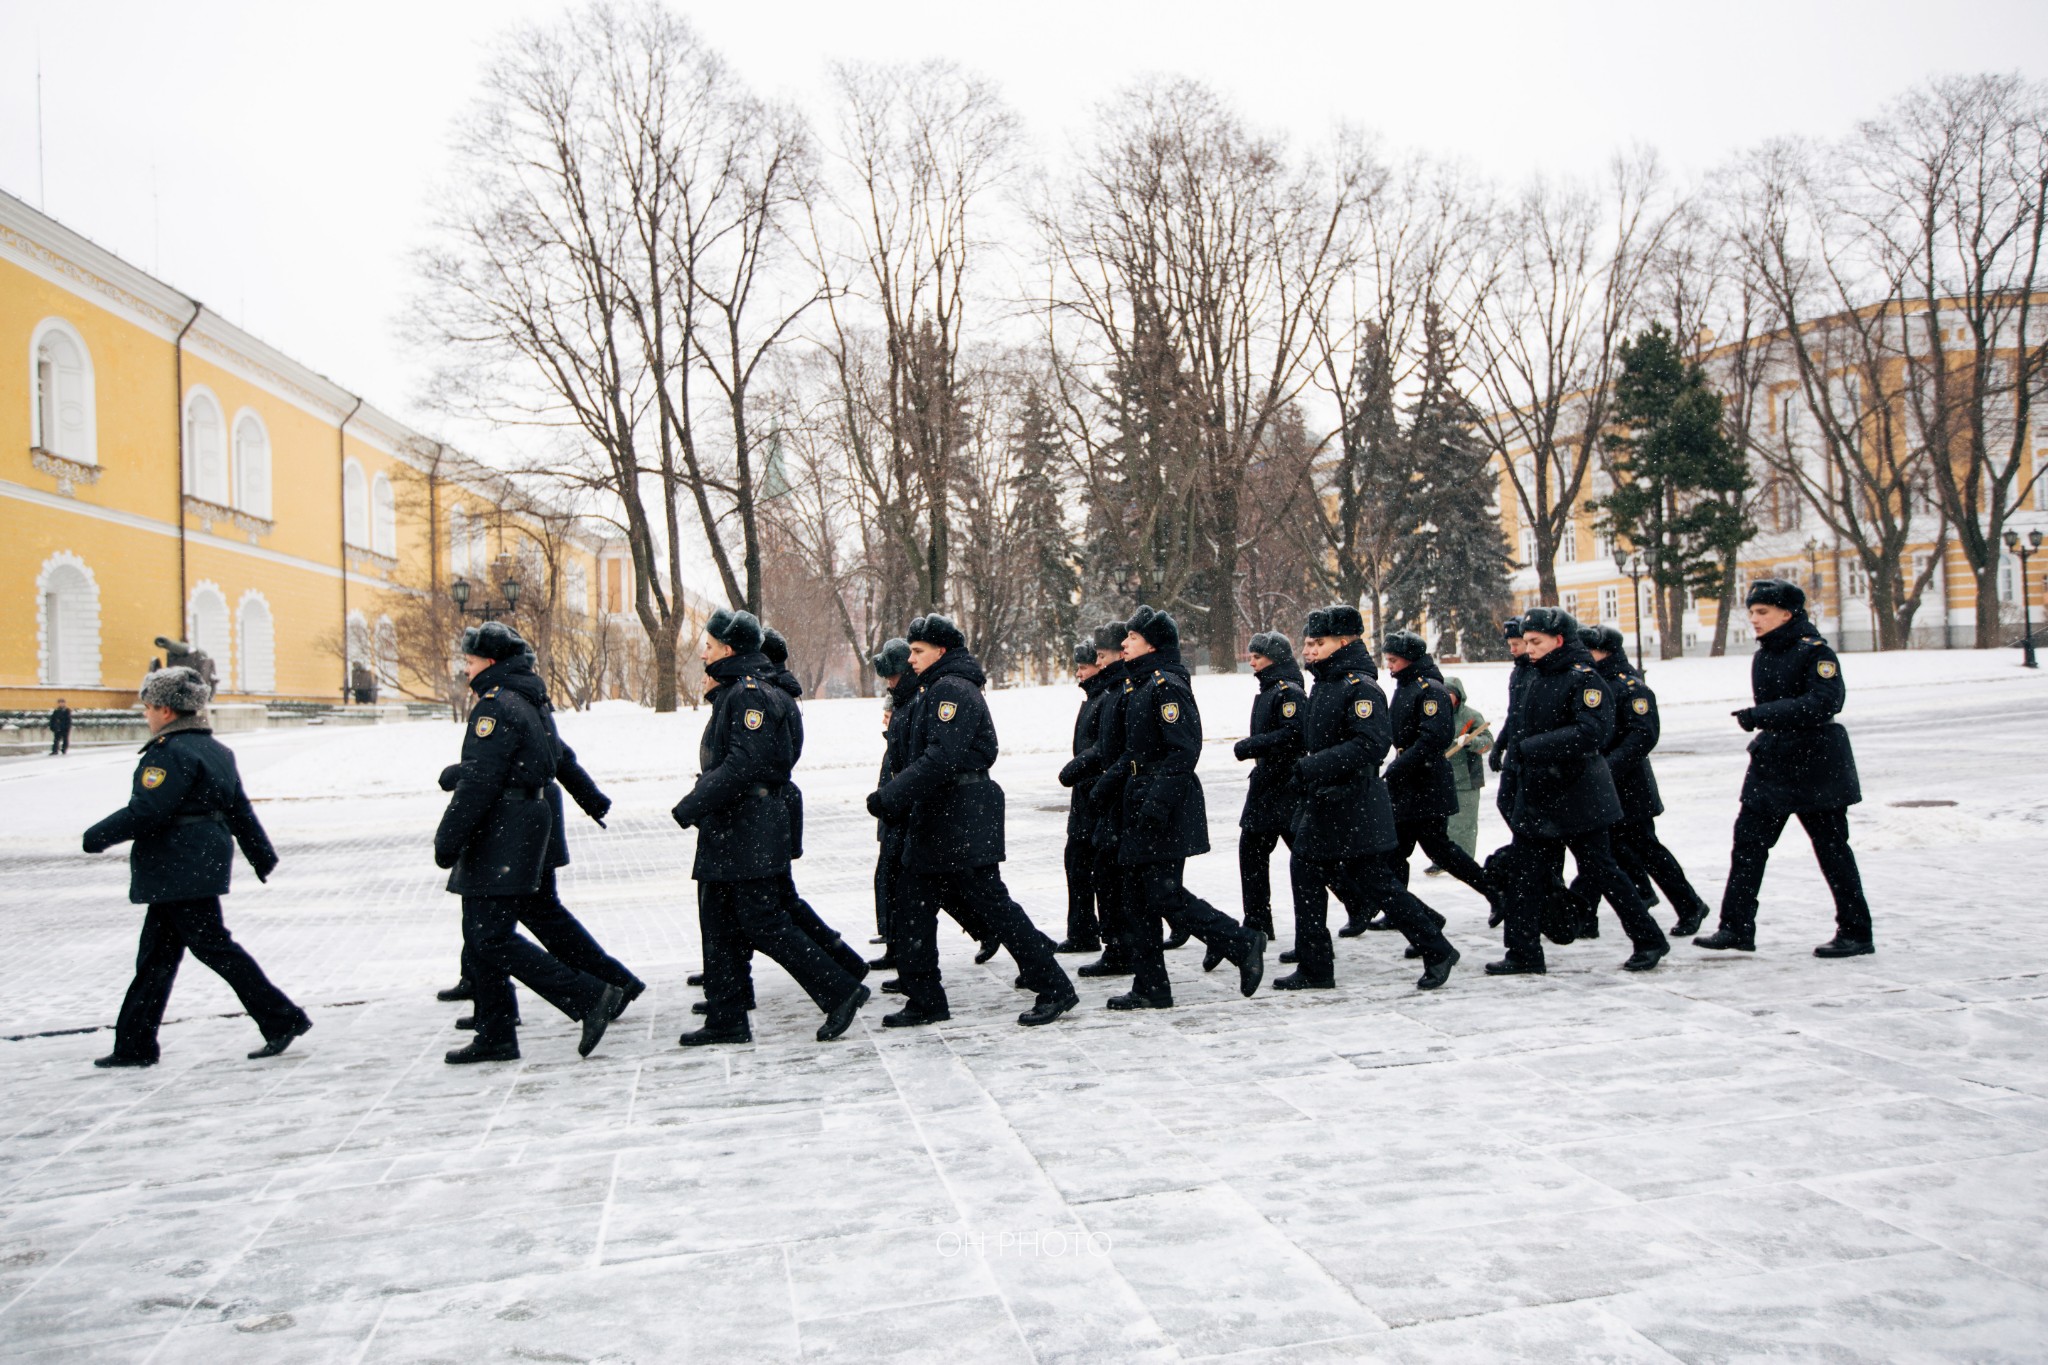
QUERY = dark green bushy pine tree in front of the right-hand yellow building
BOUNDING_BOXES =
[1593,323,1757,659]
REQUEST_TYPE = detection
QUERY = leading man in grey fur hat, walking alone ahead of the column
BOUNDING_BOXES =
[84,667,313,1066]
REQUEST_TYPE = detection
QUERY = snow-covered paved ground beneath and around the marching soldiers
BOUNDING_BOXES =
[0,653,2048,1365]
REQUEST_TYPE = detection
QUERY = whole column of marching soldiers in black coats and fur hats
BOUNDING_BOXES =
[84,579,1874,1066]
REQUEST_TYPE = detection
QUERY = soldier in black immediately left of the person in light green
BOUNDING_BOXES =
[1384,630,1495,905]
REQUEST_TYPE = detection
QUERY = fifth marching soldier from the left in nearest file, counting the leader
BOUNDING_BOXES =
[1094,606,1266,1009]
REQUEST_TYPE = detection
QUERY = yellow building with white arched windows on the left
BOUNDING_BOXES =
[0,194,637,710]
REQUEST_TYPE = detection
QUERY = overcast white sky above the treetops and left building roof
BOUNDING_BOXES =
[0,0,2048,454]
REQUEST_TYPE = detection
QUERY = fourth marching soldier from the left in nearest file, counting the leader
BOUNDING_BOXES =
[868,614,1079,1027]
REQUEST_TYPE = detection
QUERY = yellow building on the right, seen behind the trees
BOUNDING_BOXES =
[1495,304,2048,659]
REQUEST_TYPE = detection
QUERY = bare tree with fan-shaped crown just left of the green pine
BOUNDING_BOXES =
[1460,153,1671,602]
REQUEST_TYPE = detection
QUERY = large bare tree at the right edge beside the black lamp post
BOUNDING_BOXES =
[1845,76,2048,649]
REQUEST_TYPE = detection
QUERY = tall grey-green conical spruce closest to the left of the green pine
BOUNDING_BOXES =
[1391,305,1507,659]
